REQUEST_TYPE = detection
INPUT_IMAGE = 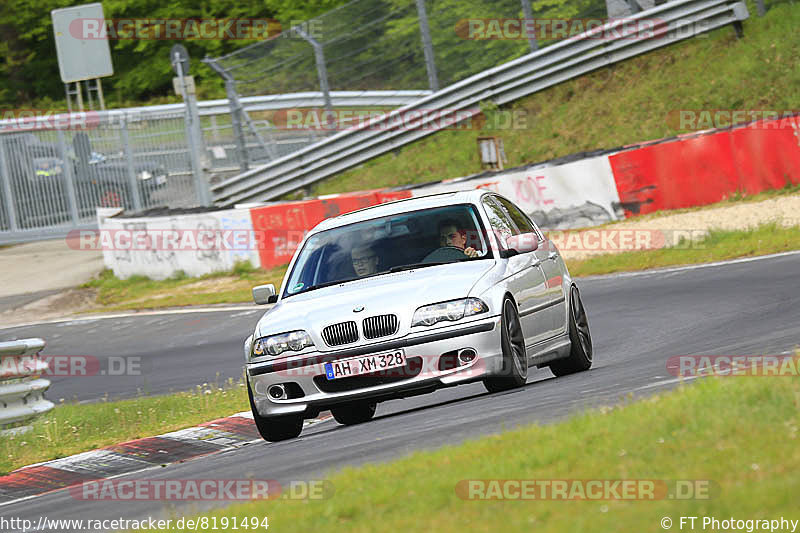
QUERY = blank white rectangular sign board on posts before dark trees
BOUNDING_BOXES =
[50,3,114,83]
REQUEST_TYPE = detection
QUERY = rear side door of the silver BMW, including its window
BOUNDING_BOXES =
[497,197,567,337]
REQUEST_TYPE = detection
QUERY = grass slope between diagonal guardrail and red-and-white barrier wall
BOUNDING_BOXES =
[300,4,800,195]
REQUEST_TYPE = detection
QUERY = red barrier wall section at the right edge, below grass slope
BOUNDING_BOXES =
[609,117,800,216]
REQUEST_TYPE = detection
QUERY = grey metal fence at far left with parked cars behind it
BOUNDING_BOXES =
[0,112,203,242]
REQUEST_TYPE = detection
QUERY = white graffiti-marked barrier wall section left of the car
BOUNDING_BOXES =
[98,209,260,279]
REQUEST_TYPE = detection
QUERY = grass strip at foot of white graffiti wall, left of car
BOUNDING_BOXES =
[83,263,286,311]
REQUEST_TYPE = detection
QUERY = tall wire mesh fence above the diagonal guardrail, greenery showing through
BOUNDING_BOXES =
[204,0,606,170]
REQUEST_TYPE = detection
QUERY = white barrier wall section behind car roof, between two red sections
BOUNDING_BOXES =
[412,156,624,229]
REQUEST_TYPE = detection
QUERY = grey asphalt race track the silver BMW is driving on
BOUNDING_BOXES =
[0,253,800,523]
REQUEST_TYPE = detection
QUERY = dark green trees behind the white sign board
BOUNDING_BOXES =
[0,0,350,107]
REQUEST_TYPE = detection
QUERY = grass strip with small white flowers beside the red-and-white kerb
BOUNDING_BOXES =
[0,379,250,475]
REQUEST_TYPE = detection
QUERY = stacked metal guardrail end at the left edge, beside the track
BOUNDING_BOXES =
[0,339,53,427]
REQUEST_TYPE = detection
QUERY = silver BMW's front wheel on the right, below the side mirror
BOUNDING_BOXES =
[483,296,528,392]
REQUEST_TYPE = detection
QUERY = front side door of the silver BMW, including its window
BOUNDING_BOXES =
[483,196,553,346]
